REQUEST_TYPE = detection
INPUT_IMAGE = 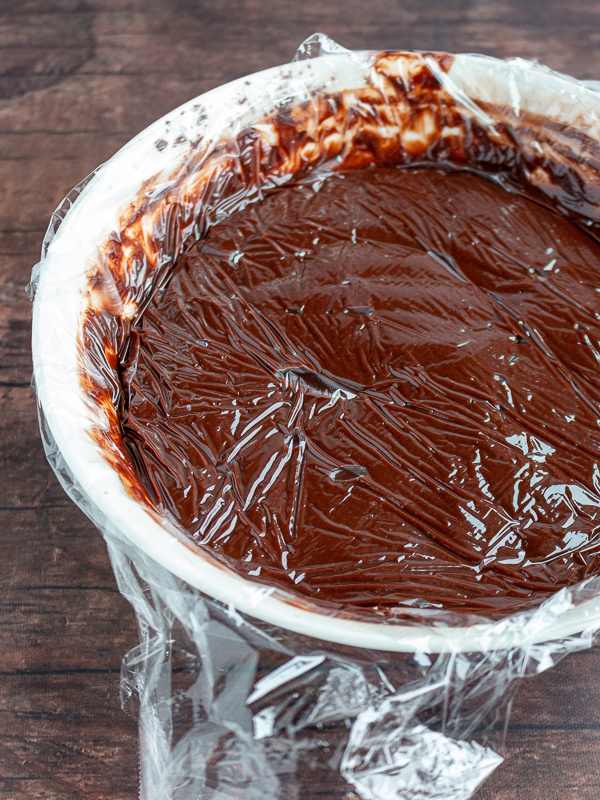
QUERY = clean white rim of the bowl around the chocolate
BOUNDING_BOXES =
[33,48,600,652]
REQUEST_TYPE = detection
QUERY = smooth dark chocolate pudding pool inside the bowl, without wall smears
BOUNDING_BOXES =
[121,168,600,614]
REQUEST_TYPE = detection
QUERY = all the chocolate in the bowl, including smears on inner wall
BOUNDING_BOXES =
[82,54,600,617]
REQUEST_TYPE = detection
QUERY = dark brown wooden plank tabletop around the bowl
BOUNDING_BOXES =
[0,0,600,800]
